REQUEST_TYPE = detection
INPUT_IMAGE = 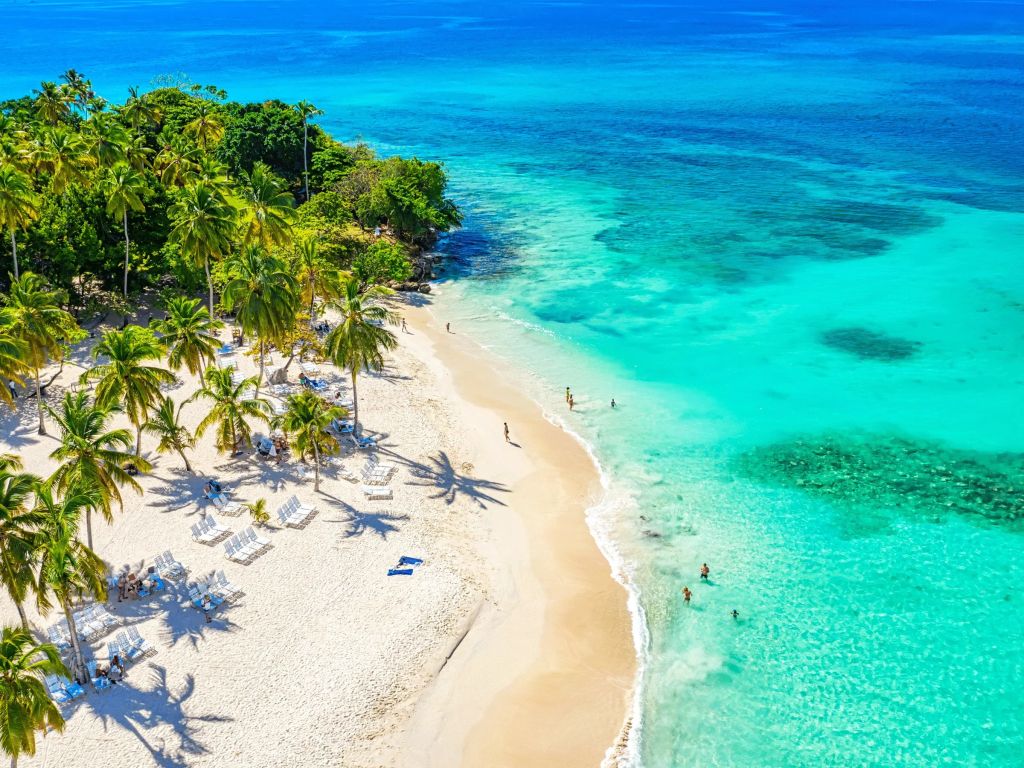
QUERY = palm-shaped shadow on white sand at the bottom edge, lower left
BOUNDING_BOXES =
[80,664,233,768]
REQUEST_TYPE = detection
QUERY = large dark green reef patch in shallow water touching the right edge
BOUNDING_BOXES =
[735,433,1024,531]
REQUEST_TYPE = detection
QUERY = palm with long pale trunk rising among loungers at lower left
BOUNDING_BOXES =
[36,483,106,682]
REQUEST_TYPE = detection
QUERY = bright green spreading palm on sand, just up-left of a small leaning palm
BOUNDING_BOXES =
[80,326,174,456]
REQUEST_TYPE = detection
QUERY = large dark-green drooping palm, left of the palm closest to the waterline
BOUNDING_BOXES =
[223,245,299,394]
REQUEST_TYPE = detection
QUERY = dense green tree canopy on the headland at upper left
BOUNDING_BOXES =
[0,71,460,306]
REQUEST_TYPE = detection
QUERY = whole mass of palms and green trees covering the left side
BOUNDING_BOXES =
[0,76,461,764]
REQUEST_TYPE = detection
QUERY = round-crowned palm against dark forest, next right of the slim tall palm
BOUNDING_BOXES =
[168,181,236,317]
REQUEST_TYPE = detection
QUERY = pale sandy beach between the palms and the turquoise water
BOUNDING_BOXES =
[0,290,635,768]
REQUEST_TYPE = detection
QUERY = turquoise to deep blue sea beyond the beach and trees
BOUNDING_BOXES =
[0,0,1024,768]
